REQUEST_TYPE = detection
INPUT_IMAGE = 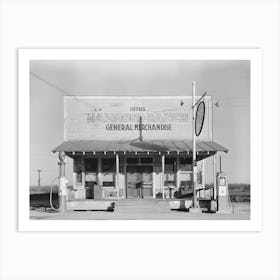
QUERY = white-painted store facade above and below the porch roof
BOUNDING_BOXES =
[64,96,212,199]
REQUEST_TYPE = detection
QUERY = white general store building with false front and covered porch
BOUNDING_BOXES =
[53,96,227,199]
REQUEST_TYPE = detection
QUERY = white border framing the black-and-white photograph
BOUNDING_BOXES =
[18,48,262,231]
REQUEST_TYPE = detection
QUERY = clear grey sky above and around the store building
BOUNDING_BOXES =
[30,60,250,185]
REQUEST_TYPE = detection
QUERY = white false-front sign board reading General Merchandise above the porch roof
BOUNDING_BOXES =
[64,96,212,140]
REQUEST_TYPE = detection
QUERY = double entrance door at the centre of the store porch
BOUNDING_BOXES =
[126,165,153,199]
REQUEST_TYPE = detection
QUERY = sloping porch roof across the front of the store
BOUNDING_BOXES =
[52,140,228,154]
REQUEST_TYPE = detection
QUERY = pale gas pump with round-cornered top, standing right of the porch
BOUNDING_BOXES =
[217,172,232,213]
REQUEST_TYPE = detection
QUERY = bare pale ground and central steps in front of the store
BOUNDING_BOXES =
[30,201,250,220]
